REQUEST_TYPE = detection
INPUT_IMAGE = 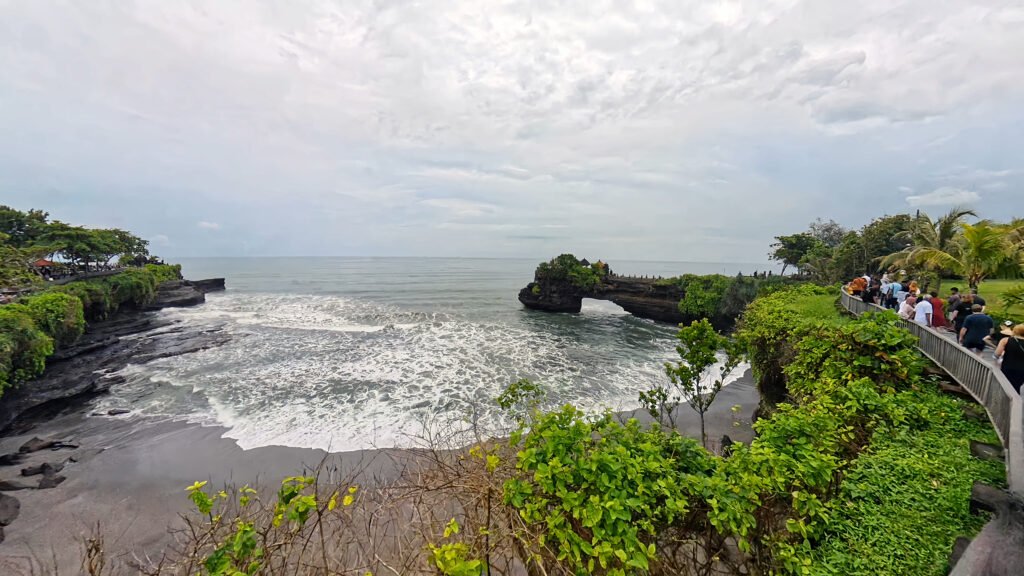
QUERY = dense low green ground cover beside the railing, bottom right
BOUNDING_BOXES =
[810,389,1005,576]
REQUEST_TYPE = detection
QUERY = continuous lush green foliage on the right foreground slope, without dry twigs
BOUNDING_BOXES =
[495,293,999,574]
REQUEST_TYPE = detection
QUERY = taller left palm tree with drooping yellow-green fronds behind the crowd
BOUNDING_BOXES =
[882,207,978,284]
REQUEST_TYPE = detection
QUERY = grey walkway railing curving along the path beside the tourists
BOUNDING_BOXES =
[841,291,1024,496]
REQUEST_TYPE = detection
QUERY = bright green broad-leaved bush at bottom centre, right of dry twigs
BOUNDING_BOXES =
[505,406,712,574]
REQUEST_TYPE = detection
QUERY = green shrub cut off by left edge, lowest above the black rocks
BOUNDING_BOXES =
[0,304,53,393]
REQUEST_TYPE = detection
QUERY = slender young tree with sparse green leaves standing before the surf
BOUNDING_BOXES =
[640,319,741,448]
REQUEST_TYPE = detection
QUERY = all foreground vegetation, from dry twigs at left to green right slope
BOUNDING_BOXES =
[163,286,1005,576]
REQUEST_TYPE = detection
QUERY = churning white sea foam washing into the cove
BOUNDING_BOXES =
[97,293,739,451]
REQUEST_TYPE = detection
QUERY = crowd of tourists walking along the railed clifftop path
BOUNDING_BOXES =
[846,274,1024,393]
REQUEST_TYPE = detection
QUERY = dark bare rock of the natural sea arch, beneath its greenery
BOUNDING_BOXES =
[519,276,704,327]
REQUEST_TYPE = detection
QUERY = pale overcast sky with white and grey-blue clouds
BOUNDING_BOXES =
[0,0,1024,262]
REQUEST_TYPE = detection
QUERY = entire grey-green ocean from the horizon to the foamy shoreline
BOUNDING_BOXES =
[98,258,765,452]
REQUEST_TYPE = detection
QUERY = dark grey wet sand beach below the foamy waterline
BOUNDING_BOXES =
[0,373,758,576]
